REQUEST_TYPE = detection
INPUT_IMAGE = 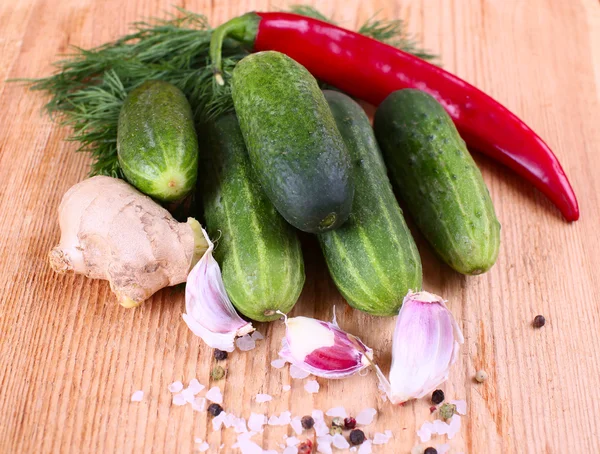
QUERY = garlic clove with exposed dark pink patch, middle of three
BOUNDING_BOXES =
[279,317,373,378]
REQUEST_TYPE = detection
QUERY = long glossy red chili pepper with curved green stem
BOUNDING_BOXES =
[211,13,579,221]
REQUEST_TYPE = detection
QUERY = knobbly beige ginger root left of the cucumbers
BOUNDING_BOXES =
[49,176,208,307]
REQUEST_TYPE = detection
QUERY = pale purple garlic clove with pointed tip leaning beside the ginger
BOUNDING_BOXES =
[183,229,254,352]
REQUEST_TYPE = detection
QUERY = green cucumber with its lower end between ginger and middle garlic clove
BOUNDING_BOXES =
[200,114,304,321]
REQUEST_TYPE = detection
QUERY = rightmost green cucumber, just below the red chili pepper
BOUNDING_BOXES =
[374,89,500,274]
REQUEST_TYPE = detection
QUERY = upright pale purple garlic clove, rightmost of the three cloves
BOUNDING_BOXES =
[376,292,464,404]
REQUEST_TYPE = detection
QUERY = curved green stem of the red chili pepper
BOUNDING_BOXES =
[210,13,260,86]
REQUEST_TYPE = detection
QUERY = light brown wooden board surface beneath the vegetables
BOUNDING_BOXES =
[0,0,600,454]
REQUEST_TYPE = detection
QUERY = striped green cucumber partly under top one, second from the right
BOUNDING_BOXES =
[318,90,422,315]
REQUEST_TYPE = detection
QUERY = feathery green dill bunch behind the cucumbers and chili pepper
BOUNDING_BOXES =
[21,5,432,178]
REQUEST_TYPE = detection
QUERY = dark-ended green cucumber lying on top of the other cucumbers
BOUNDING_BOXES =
[231,52,354,233]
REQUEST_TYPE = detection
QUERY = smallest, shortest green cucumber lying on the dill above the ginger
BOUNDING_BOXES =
[117,80,198,202]
